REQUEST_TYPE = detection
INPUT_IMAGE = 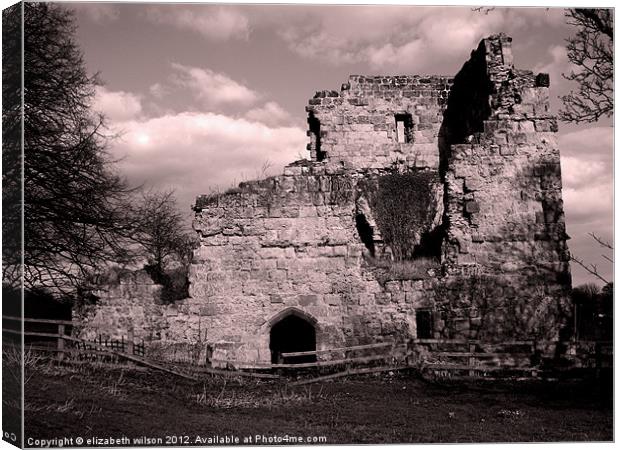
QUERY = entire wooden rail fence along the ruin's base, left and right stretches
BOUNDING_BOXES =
[2,316,613,380]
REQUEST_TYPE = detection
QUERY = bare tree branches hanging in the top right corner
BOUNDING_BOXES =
[560,9,614,123]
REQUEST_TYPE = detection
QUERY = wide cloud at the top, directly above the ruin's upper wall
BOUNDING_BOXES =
[279,7,508,71]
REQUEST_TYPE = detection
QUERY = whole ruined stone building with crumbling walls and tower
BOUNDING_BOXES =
[78,34,570,364]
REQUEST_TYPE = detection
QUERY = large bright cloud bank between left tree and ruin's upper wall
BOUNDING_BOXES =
[112,112,307,208]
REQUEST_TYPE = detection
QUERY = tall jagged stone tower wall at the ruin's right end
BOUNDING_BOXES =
[443,35,570,339]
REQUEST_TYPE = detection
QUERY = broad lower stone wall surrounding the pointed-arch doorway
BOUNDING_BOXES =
[179,162,446,361]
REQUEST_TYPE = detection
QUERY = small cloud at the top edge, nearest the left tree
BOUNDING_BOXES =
[146,5,250,41]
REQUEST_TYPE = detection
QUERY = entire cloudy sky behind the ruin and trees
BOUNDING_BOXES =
[63,3,613,285]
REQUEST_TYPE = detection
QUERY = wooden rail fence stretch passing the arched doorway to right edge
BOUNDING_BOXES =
[212,339,613,379]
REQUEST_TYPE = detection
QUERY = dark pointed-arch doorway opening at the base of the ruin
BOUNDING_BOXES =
[269,314,316,364]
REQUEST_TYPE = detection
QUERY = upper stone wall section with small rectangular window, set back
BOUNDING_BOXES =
[306,75,452,169]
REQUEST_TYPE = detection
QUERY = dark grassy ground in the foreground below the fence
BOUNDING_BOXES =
[25,366,613,445]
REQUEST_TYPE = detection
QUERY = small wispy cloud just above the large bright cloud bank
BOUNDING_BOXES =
[172,63,259,106]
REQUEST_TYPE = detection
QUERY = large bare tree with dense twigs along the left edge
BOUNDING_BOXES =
[2,2,131,293]
